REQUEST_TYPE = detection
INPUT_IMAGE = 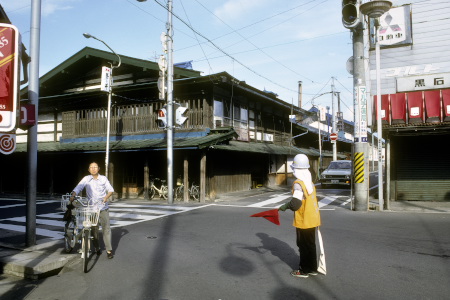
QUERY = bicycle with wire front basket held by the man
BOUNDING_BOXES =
[61,194,103,273]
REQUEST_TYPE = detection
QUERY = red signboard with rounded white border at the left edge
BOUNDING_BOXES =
[0,24,20,132]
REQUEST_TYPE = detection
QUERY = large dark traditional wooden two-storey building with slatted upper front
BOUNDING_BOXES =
[0,48,351,201]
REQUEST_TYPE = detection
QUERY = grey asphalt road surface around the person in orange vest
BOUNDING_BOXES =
[3,189,450,300]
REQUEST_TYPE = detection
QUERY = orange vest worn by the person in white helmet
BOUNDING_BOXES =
[292,180,320,229]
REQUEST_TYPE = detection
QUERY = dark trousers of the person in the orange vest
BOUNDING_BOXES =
[296,227,317,273]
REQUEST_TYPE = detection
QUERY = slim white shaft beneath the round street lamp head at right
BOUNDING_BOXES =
[375,19,384,211]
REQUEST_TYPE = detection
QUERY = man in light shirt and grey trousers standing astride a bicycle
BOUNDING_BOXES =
[70,162,114,258]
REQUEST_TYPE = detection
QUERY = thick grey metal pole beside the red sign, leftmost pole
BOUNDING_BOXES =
[26,0,41,247]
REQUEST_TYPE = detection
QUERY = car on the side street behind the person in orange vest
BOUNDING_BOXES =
[320,160,352,188]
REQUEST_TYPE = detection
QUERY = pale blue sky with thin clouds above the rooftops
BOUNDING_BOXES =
[1,0,353,121]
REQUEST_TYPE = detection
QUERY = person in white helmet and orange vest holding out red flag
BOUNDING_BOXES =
[278,154,320,278]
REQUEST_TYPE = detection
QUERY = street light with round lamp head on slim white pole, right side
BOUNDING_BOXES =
[360,0,392,210]
